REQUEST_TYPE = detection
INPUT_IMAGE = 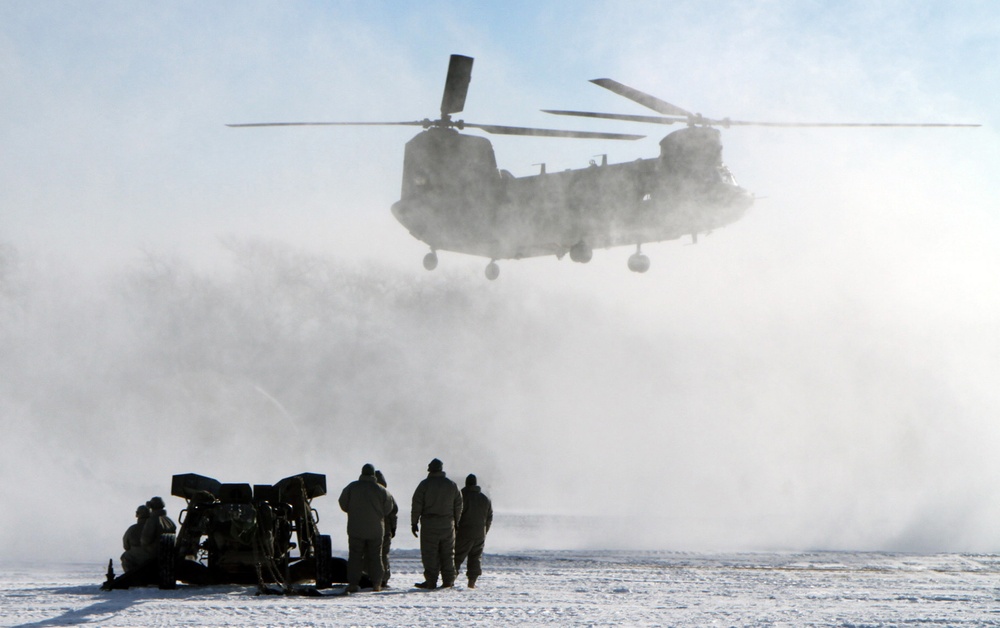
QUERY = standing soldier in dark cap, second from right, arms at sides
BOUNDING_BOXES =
[410,458,462,589]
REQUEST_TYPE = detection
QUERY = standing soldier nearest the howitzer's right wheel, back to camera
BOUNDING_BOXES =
[340,464,394,593]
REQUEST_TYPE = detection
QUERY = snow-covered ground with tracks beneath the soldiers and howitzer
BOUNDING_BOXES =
[0,550,1000,626]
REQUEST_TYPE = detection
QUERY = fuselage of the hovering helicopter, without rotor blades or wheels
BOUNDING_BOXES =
[392,127,753,261]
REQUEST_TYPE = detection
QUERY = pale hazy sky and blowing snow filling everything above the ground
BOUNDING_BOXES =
[0,1,1000,561]
